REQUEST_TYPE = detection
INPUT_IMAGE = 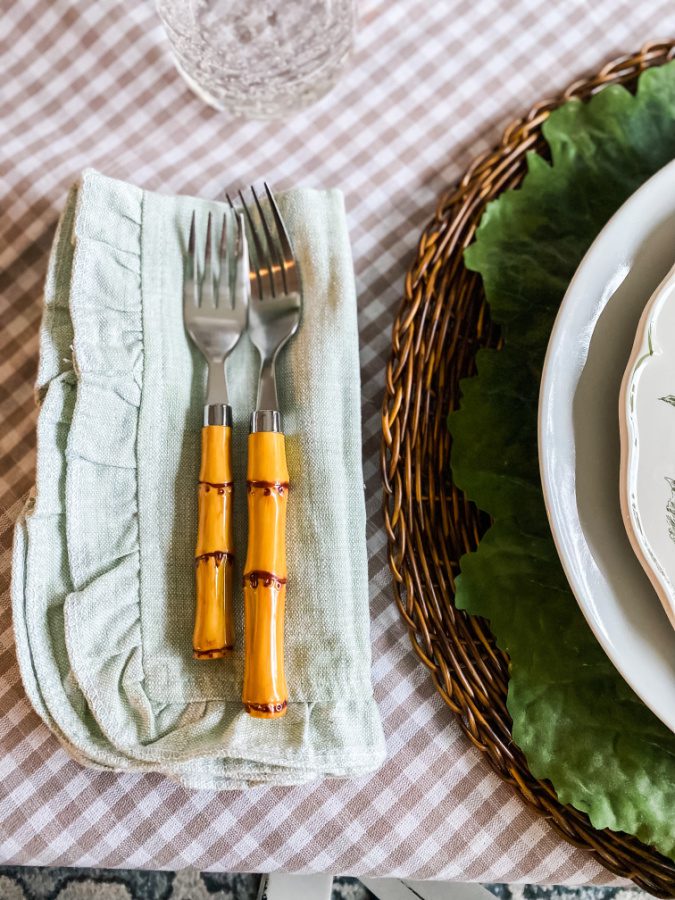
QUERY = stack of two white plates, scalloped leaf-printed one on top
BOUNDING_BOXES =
[539,156,675,731]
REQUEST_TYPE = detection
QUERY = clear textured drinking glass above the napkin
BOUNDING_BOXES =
[157,0,355,118]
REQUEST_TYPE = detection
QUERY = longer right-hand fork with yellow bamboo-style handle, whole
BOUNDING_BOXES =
[228,185,302,719]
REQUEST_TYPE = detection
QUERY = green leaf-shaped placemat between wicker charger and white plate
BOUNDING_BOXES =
[449,63,675,859]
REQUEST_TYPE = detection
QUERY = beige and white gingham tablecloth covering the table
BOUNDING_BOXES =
[0,0,675,884]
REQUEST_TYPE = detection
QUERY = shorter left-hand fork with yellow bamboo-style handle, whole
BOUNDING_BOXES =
[183,213,249,659]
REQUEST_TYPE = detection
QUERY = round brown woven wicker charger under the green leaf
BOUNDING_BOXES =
[382,41,675,897]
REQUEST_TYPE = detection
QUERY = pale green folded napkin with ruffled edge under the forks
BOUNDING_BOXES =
[12,171,385,789]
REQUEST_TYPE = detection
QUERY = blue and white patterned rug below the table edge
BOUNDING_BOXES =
[0,866,649,900]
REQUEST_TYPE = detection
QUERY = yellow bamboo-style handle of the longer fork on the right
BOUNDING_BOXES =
[242,431,288,719]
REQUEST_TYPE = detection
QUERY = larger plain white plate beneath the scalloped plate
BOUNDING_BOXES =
[539,156,675,731]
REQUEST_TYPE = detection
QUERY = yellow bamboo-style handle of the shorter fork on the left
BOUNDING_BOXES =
[192,425,234,659]
